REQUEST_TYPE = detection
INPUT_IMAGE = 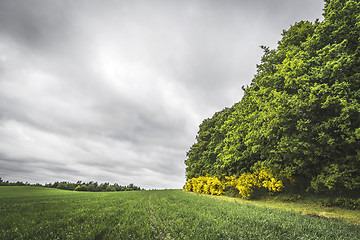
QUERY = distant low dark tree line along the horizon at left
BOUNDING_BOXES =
[0,178,145,192]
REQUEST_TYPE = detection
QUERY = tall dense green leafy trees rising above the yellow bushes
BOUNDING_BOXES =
[185,0,360,192]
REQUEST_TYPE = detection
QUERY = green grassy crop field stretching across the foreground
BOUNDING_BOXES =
[0,187,360,239]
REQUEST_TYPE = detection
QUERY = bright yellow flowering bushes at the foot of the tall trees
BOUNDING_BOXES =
[185,167,294,199]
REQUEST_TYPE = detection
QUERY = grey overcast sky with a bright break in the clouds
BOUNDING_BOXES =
[0,0,323,189]
